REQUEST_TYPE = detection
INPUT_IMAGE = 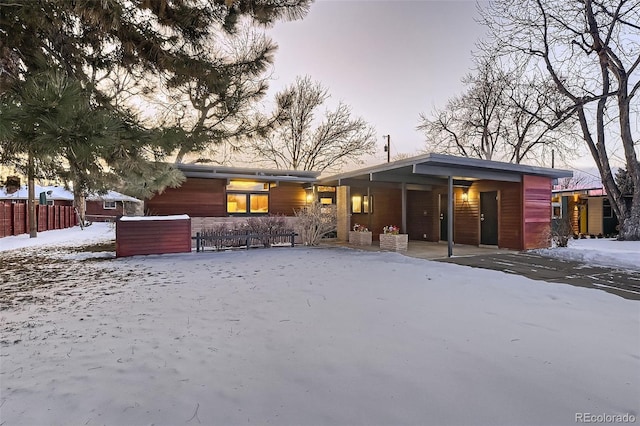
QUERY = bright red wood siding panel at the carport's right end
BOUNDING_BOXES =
[522,176,551,249]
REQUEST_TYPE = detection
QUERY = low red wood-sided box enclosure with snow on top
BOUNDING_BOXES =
[116,216,191,257]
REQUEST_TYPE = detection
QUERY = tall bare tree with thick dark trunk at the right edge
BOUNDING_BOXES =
[483,0,640,240]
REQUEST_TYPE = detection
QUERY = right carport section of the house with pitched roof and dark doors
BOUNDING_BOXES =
[318,154,573,255]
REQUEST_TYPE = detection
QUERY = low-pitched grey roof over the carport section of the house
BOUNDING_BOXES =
[318,153,573,185]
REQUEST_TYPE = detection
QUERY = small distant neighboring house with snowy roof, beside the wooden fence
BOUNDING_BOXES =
[85,191,144,222]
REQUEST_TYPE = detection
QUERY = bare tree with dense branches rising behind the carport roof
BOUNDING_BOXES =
[418,49,573,164]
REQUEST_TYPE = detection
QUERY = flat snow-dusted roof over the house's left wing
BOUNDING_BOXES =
[174,163,320,183]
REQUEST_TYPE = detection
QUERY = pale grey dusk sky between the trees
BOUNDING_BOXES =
[268,0,604,175]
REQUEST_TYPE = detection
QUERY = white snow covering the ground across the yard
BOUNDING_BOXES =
[0,224,640,425]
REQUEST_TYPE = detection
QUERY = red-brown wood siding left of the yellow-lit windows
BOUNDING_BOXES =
[145,178,227,217]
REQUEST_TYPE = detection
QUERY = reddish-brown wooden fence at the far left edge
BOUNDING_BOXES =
[0,201,78,238]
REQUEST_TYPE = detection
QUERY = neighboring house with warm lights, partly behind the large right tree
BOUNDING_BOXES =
[551,188,618,236]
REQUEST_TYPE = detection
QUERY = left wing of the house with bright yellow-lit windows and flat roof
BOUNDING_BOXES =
[145,164,320,233]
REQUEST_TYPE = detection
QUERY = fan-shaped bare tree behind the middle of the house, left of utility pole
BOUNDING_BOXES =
[251,76,375,171]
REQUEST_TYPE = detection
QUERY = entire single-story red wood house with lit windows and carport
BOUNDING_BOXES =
[145,154,573,255]
